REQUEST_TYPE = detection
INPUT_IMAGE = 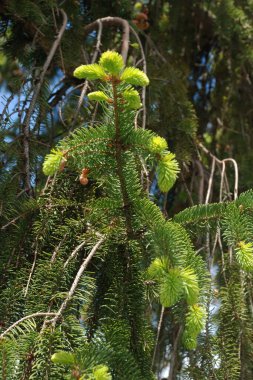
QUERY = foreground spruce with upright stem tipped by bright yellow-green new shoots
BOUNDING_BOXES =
[2,51,209,379]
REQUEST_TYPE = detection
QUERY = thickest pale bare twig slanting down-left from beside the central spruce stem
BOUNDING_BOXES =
[48,236,105,326]
